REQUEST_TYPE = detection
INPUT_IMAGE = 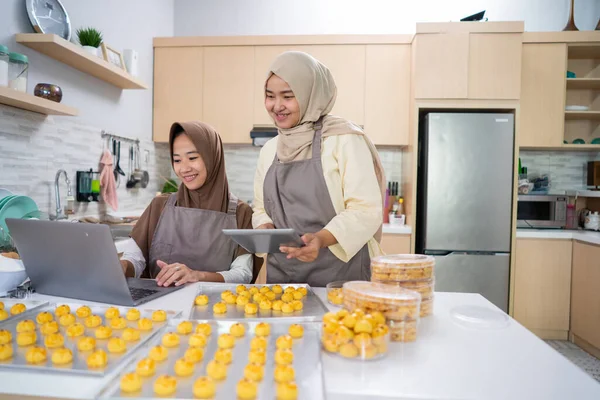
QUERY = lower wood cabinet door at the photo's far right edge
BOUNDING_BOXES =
[571,242,600,348]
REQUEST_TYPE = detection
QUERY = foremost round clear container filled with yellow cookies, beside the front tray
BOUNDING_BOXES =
[321,310,391,361]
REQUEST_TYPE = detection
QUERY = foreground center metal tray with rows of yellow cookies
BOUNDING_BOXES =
[99,318,325,400]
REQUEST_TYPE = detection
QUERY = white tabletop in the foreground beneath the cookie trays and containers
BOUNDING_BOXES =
[0,284,600,400]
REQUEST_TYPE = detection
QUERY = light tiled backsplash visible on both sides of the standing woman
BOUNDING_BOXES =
[225,145,402,201]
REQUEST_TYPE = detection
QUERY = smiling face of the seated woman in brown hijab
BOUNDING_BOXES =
[173,133,207,190]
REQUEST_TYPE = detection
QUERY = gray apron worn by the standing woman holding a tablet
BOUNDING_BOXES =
[263,120,371,287]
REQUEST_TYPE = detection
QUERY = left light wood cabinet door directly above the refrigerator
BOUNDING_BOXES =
[413,33,469,99]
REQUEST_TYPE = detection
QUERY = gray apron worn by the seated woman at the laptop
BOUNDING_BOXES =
[148,193,238,278]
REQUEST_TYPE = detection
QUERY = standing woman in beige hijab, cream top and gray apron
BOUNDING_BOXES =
[252,51,385,286]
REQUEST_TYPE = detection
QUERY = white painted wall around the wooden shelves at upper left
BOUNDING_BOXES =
[0,0,174,139]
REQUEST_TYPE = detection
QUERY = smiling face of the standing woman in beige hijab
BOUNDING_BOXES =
[265,74,300,129]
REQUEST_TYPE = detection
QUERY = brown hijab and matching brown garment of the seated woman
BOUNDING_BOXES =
[131,121,260,278]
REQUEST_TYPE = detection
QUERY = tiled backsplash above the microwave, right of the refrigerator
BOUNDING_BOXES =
[520,151,600,190]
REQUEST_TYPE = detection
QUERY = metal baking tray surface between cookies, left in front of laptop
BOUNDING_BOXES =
[0,302,181,376]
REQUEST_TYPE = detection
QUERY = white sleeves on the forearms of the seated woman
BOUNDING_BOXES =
[119,239,253,283]
